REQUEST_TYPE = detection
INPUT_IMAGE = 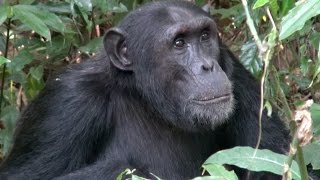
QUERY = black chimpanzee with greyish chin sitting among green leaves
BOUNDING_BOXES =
[0,1,289,180]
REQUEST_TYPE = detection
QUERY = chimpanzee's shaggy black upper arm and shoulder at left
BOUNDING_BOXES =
[0,62,110,179]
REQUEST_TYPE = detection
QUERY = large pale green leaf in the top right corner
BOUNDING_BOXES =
[279,0,320,40]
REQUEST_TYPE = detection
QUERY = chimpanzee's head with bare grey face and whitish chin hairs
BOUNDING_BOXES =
[107,2,234,130]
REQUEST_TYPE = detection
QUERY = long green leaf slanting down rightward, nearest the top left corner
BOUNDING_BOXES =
[13,5,51,41]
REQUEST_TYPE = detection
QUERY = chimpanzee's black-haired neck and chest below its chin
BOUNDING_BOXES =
[107,92,218,179]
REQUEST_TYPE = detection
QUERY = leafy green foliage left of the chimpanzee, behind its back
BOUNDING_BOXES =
[0,0,134,156]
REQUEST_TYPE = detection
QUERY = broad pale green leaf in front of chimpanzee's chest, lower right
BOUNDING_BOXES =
[204,147,301,179]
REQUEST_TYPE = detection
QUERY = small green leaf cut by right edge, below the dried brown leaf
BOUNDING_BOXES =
[303,143,320,169]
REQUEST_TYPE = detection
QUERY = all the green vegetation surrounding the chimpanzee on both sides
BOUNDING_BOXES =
[0,0,320,180]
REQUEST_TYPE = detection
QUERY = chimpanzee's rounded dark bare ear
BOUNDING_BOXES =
[103,28,132,71]
